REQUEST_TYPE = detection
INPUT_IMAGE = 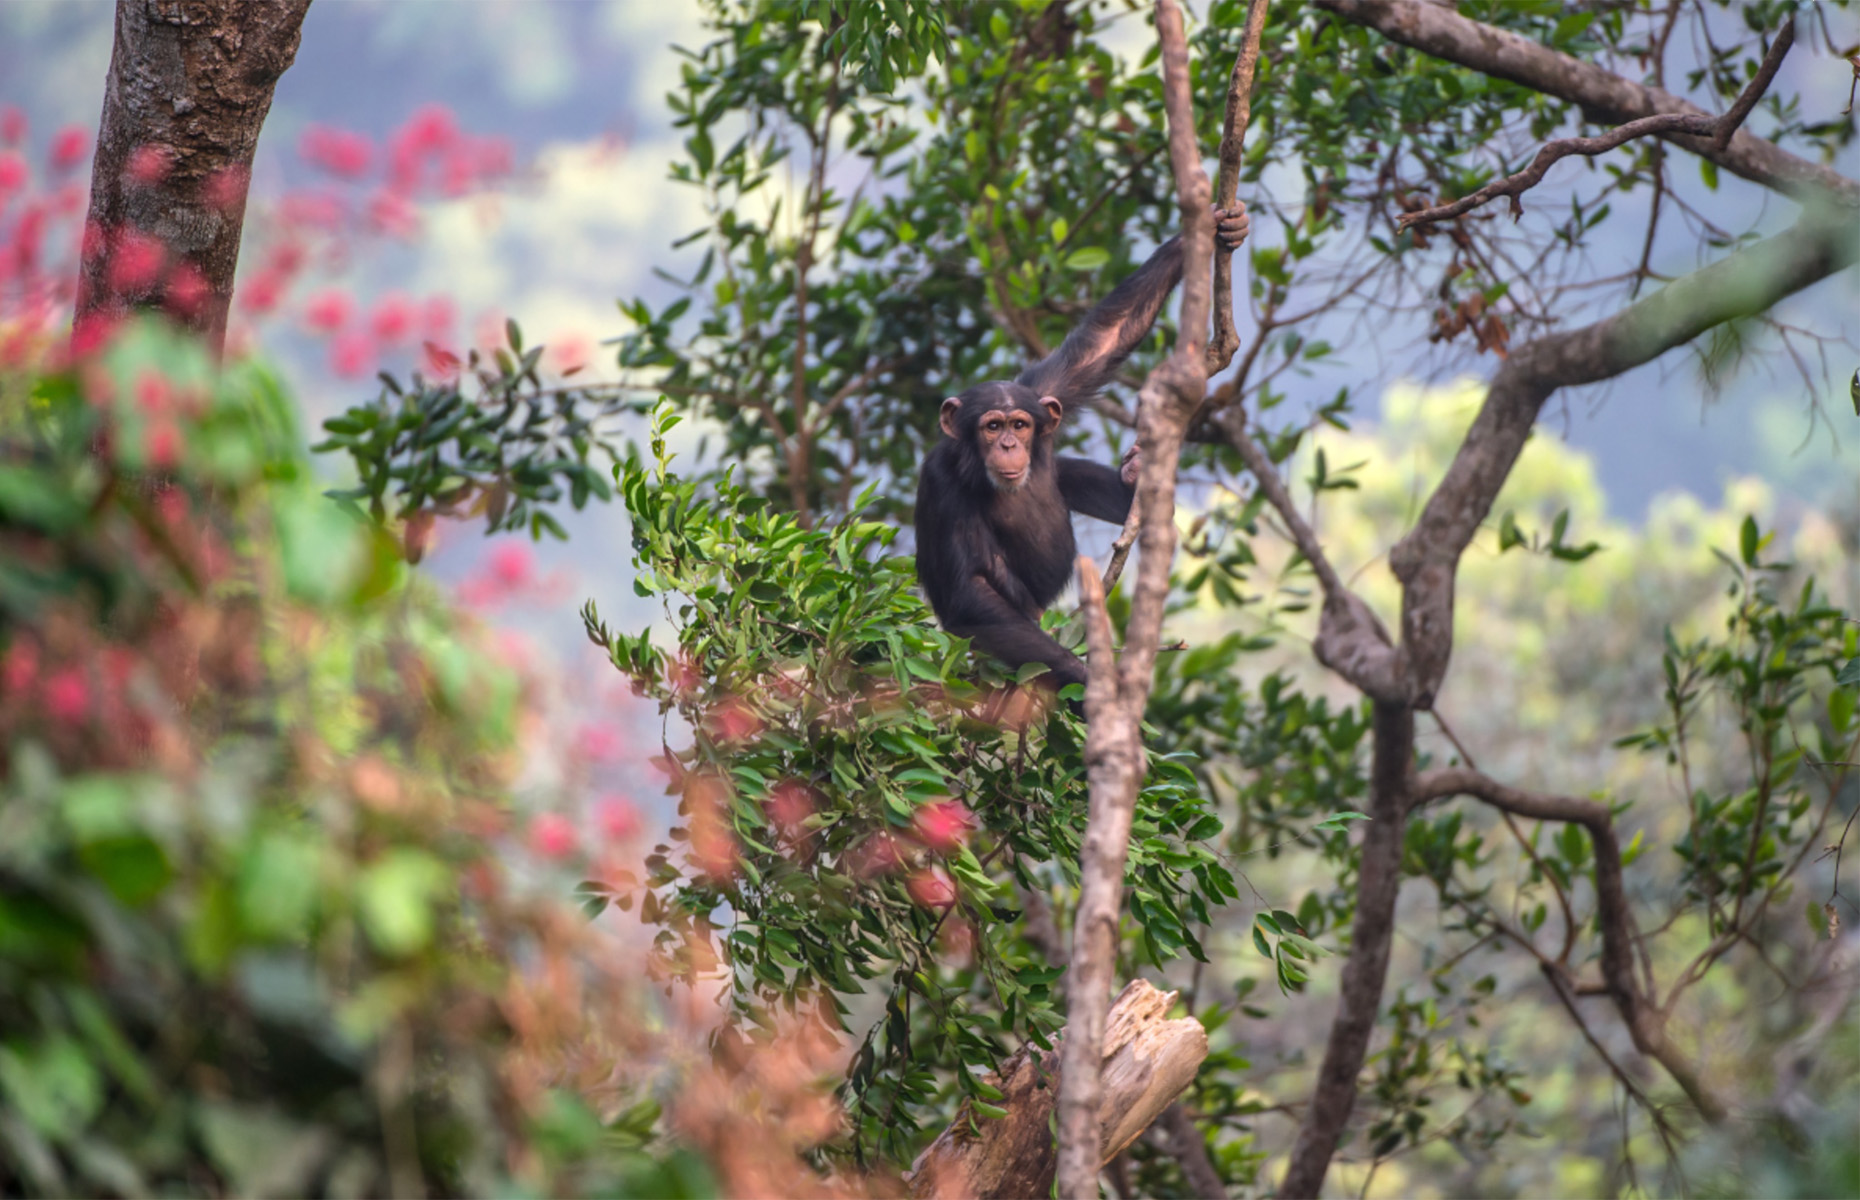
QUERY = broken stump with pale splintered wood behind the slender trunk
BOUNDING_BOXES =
[911,979,1207,1200]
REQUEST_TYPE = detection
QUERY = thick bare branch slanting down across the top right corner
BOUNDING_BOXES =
[1313,0,1860,207]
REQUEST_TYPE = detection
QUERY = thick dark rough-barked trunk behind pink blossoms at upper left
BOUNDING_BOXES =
[76,0,311,355]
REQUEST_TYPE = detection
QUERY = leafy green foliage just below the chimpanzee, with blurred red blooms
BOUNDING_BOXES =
[586,405,1242,1161]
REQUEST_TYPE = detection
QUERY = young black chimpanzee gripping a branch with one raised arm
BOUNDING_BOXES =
[917,205,1248,688]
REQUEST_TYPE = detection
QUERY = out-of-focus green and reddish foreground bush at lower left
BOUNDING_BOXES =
[0,326,699,1196]
